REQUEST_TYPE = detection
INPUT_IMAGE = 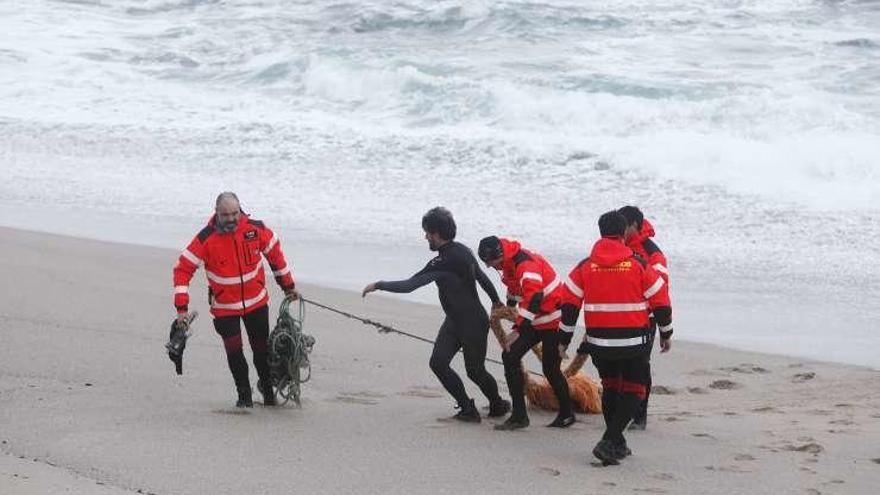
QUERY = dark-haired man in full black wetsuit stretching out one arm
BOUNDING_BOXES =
[363,206,510,423]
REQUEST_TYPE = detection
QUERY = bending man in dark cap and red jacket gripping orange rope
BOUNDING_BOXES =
[478,236,575,430]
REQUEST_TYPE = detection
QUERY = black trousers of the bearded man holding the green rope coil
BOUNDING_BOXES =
[214,305,269,393]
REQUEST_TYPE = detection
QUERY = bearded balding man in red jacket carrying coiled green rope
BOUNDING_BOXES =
[173,192,299,407]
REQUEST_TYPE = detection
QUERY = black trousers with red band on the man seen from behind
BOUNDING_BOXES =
[593,350,651,443]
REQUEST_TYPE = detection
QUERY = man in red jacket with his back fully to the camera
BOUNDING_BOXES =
[562,211,672,465]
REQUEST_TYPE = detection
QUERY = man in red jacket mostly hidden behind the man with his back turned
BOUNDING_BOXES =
[617,206,669,430]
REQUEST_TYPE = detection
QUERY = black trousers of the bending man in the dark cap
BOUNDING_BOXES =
[501,326,572,418]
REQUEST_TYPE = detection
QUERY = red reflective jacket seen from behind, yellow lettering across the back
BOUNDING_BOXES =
[562,238,672,357]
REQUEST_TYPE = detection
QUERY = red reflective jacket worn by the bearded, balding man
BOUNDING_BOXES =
[173,213,294,316]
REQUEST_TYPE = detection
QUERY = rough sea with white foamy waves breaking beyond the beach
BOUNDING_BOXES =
[0,0,880,362]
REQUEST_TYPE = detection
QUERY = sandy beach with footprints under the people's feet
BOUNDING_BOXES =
[0,229,880,495]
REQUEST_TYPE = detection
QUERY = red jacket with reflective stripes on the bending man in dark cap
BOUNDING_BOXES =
[501,239,563,330]
